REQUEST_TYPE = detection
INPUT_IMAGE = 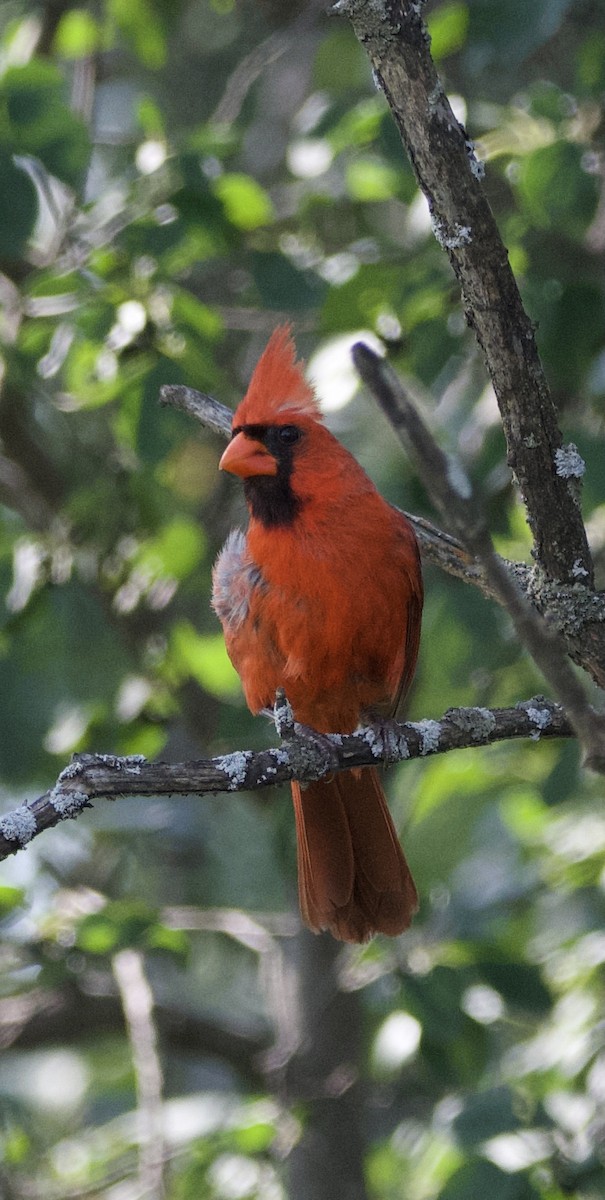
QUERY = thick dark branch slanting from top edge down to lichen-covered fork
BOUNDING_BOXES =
[333,0,593,586]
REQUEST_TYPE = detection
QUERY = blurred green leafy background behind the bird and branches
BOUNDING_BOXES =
[0,0,605,1200]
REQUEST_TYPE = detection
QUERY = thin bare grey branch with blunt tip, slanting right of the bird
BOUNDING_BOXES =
[353,342,605,772]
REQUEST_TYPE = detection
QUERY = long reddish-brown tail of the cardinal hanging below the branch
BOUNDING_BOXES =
[292,767,418,942]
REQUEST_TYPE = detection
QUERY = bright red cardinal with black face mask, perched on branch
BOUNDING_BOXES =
[212,328,423,942]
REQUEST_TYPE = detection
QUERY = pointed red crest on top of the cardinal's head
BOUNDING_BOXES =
[233,325,322,426]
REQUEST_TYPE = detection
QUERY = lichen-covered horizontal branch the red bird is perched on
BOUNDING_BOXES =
[0,696,574,860]
